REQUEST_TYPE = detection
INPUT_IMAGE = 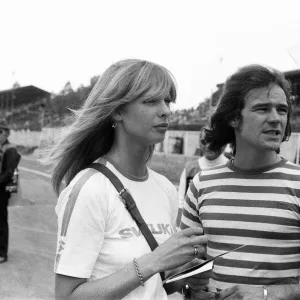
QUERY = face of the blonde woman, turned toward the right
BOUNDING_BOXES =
[118,91,171,146]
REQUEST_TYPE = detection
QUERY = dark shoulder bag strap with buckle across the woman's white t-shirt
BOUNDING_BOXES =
[88,163,164,280]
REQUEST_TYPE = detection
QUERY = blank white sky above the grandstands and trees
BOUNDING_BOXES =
[0,0,300,109]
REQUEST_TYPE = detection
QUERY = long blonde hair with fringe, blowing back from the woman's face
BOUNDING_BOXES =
[50,59,176,193]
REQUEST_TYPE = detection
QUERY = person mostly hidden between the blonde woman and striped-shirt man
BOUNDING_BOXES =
[177,127,228,226]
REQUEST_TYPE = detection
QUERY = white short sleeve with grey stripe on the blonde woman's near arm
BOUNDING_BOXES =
[54,171,108,278]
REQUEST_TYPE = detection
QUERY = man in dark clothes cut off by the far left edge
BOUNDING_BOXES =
[0,121,20,263]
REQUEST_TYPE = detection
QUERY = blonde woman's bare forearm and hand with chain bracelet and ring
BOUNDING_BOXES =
[55,228,207,300]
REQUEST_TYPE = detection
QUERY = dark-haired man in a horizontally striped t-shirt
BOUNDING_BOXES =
[181,65,300,300]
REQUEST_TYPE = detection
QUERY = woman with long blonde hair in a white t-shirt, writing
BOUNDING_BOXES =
[52,59,206,300]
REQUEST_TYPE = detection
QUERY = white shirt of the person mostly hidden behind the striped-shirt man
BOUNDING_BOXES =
[178,153,228,208]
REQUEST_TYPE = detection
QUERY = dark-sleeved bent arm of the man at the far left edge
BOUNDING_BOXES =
[0,148,20,187]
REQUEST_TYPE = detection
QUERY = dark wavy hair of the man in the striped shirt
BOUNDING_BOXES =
[205,65,292,154]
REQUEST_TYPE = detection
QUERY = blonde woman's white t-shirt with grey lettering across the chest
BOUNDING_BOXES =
[54,161,178,300]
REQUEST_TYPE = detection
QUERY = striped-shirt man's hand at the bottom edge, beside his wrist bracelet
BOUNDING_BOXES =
[216,285,264,300]
